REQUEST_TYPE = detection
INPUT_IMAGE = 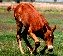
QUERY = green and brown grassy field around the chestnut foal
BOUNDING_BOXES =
[0,7,63,56]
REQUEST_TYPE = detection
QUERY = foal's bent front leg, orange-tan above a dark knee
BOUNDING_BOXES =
[28,27,40,53]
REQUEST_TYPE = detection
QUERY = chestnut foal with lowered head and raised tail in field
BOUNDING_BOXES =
[7,3,56,54]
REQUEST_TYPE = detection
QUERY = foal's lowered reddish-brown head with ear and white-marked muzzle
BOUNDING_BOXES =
[44,26,56,52]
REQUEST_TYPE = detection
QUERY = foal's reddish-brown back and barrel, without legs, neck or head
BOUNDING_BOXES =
[14,3,48,31]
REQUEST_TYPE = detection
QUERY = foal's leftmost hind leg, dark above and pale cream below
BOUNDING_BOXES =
[16,22,24,54]
